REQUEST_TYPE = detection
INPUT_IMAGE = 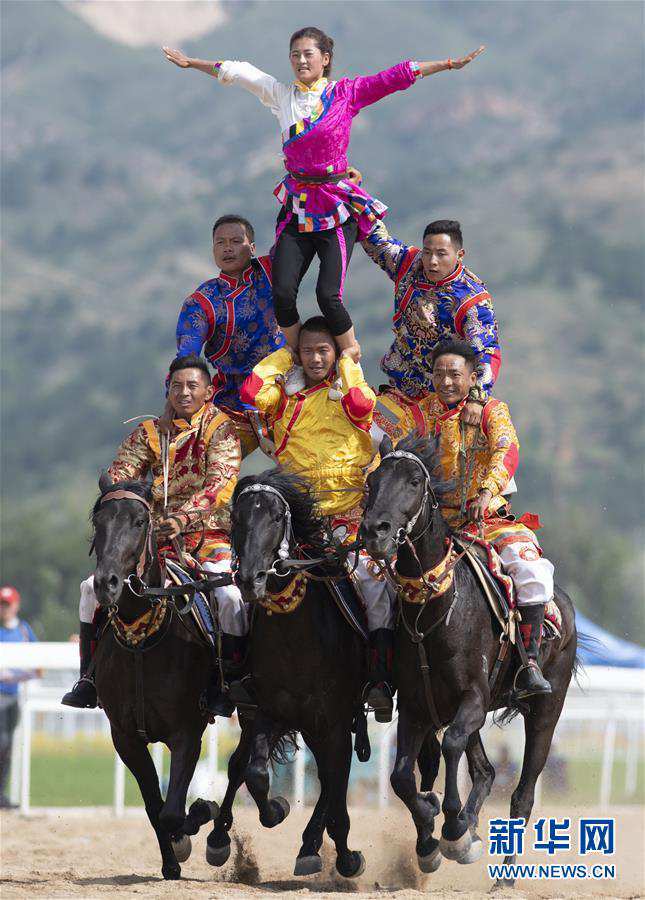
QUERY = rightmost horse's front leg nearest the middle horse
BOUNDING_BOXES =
[390,707,441,872]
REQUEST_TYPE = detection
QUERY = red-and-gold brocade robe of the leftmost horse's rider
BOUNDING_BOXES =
[108,403,241,559]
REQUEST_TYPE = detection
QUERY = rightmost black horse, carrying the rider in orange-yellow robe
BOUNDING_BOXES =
[361,435,577,871]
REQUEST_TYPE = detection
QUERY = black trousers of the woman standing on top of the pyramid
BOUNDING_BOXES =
[273,214,358,335]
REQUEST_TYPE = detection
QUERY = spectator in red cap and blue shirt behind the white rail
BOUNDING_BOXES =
[0,585,39,809]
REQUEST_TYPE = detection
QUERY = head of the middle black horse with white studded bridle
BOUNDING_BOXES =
[231,469,321,603]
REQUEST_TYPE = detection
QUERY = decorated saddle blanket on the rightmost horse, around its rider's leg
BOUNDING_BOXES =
[455,535,562,639]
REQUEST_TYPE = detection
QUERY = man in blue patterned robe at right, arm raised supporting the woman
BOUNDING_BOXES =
[363,219,501,425]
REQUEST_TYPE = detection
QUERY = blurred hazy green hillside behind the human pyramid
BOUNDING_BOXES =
[0,0,645,640]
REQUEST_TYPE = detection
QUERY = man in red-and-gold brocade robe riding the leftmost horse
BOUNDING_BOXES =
[62,356,248,715]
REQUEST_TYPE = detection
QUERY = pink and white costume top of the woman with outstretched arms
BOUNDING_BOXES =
[218,60,421,240]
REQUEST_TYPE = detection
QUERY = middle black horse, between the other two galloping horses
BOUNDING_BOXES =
[207,470,366,878]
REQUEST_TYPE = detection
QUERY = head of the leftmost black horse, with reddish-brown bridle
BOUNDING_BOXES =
[91,472,156,606]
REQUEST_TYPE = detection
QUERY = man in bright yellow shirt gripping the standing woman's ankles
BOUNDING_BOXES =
[241,316,394,721]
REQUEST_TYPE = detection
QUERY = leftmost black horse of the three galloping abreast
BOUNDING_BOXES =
[92,474,218,879]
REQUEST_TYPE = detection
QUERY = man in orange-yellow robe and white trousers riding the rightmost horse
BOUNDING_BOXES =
[421,341,554,699]
